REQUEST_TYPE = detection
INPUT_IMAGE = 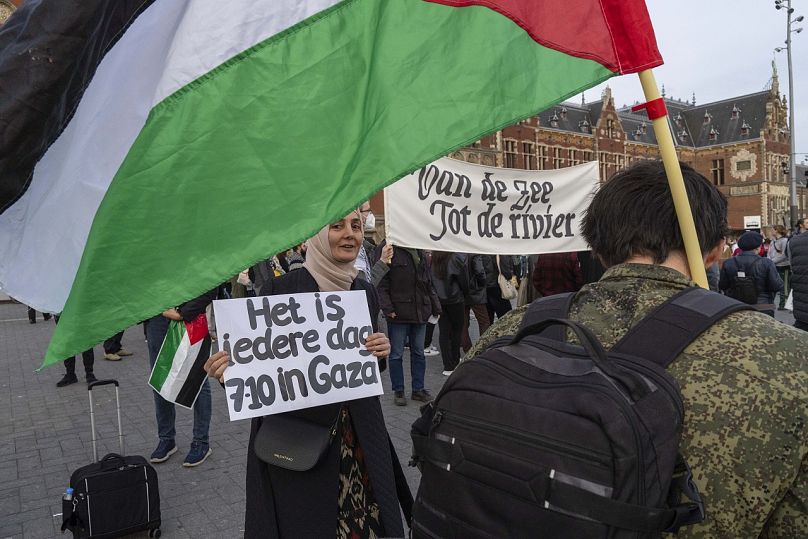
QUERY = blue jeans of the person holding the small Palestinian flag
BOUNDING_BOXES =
[146,316,212,444]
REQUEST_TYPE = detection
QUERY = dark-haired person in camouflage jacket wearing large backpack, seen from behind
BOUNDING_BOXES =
[422,161,808,539]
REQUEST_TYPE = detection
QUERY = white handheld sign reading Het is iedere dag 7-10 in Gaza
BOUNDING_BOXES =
[213,291,383,421]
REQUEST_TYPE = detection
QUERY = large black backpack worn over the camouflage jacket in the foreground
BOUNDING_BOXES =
[410,288,751,539]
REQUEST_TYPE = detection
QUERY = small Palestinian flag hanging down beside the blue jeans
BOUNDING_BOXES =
[149,313,210,408]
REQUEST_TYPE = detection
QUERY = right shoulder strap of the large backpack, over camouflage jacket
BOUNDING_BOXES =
[610,287,755,367]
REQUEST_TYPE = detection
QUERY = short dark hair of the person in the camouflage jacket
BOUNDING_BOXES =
[581,161,729,266]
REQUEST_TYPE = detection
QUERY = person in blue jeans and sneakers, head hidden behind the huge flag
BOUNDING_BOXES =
[146,289,217,467]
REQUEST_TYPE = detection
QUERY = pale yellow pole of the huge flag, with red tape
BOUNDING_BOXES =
[639,69,708,288]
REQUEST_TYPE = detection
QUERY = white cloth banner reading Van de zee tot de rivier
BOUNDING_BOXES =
[384,157,599,254]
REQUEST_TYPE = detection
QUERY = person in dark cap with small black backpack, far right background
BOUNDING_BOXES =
[718,232,783,317]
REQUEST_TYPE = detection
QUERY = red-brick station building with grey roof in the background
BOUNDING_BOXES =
[450,67,808,230]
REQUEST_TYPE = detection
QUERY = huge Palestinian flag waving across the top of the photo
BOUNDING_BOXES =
[0,0,662,364]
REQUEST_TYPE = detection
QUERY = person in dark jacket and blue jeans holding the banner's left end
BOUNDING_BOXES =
[375,241,441,406]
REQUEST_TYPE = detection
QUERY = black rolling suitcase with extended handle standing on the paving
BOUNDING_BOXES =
[62,380,160,539]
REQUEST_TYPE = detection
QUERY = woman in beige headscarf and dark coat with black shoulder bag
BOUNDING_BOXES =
[205,212,404,538]
